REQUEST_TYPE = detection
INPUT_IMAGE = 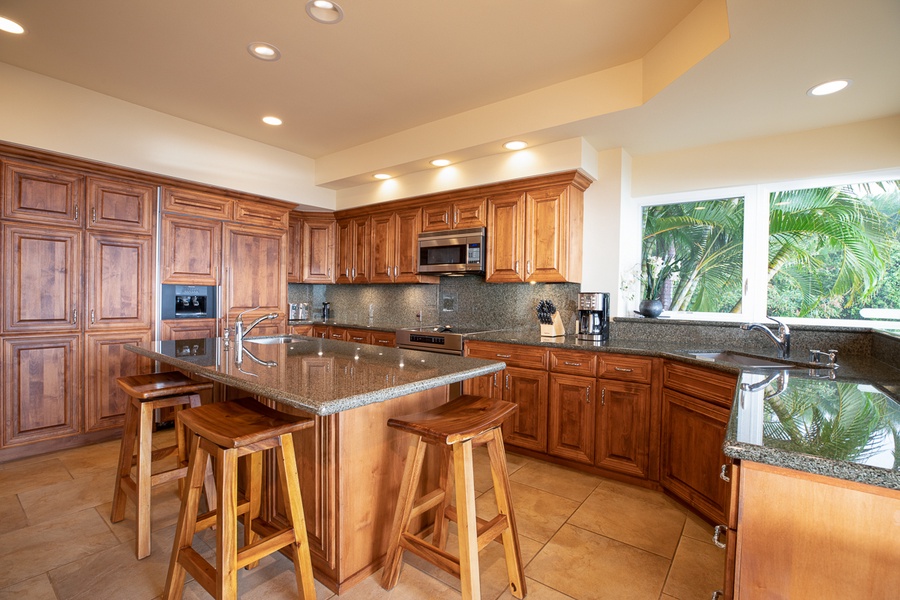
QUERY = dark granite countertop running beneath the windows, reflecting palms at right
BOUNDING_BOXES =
[467,330,900,490]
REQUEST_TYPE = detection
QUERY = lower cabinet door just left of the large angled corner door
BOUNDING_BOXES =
[596,379,650,478]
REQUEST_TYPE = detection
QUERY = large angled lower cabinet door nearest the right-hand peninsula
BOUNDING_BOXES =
[659,388,729,523]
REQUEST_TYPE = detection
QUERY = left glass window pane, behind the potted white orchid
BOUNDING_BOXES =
[641,198,744,313]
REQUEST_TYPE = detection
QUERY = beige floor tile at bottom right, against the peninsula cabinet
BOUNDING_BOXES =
[663,537,725,600]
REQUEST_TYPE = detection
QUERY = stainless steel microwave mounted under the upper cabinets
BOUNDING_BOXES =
[419,227,485,275]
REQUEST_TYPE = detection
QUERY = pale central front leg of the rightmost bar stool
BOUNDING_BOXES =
[453,440,481,600]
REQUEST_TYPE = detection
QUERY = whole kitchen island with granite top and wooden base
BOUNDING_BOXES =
[126,336,505,593]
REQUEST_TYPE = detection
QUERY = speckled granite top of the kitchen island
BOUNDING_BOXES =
[125,336,506,415]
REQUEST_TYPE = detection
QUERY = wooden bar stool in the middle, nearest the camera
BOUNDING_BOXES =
[163,398,316,600]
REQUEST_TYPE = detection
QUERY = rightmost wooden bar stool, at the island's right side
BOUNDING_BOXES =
[381,396,525,600]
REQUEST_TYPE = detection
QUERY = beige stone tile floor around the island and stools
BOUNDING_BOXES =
[0,432,725,600]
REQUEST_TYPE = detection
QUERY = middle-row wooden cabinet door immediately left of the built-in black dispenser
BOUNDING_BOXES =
[85,232,153,329]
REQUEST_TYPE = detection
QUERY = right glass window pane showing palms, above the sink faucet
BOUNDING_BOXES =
[767,181,900,320]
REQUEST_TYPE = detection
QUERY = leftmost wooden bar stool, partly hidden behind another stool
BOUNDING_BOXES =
[110,371,215,559]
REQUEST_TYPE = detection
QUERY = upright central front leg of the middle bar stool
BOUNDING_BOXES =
[216,448,238,600]
